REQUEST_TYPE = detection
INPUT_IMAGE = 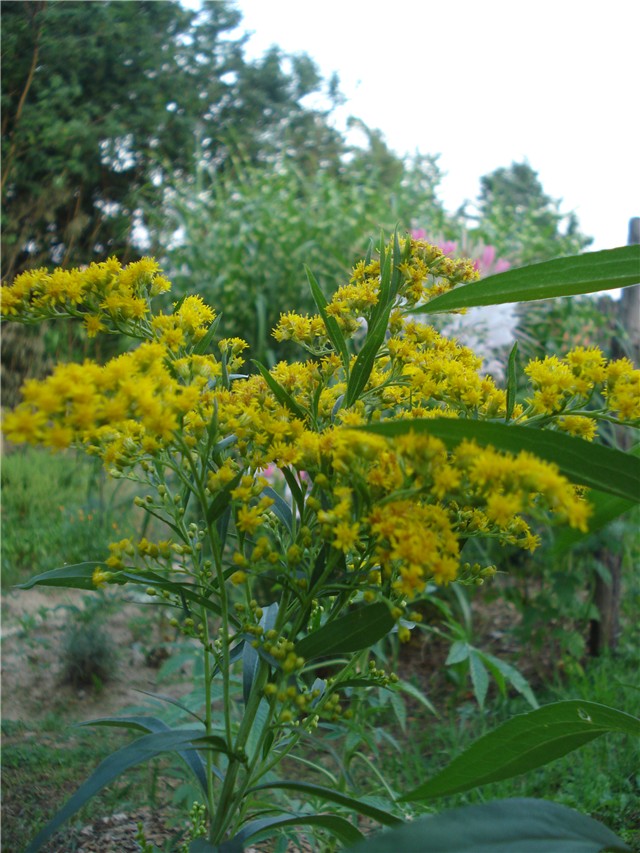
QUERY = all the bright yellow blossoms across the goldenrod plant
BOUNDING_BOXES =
[3,233,624,601]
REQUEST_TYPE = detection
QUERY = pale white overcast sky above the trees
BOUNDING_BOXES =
[221,0,640,250]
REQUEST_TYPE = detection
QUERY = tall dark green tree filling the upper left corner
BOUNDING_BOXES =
[2,0,340,280]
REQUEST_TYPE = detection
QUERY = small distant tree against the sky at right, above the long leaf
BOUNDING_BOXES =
[461,162,592,264]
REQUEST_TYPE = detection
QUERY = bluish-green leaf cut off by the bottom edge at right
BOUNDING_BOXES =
[345,798,631,853]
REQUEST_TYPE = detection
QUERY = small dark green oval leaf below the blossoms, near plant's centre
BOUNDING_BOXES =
[296,601,395,660]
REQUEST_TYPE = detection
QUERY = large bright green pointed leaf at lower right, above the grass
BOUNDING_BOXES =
[400,700,640,802]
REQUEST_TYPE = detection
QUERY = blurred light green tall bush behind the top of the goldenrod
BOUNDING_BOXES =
[153,151,445,365]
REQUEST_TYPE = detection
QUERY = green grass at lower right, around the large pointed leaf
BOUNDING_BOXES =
[384,654,640,851]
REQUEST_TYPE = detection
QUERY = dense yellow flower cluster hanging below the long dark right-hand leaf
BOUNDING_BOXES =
[315,428,590,598]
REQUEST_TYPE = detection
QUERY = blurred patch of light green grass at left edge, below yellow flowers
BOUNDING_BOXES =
[1,448,140,589]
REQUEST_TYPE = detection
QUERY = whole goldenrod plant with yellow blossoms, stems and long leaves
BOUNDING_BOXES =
[2,234,640,853]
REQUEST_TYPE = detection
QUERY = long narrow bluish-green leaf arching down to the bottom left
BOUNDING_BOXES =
[27,729,227,853]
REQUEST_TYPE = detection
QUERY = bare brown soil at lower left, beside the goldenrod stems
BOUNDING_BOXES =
[2,588,194,853]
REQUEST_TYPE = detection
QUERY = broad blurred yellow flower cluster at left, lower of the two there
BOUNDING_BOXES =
[3,341,220,468]
